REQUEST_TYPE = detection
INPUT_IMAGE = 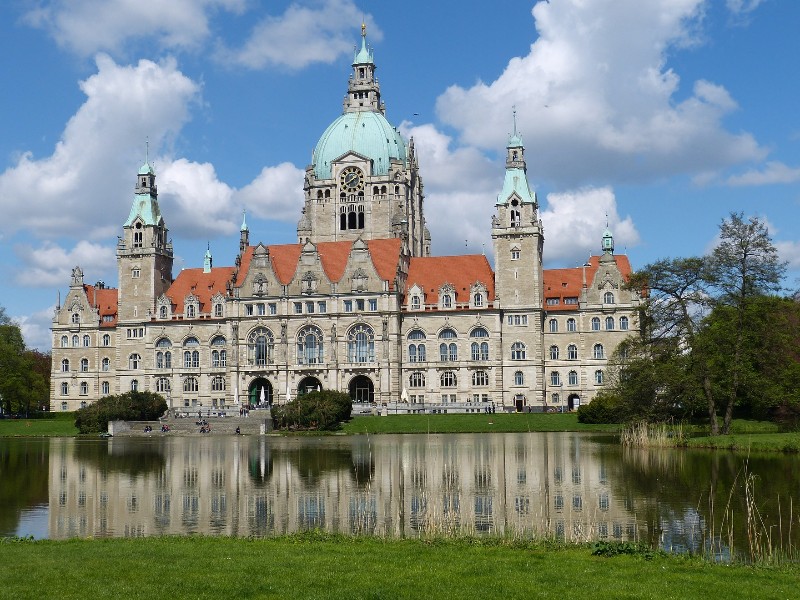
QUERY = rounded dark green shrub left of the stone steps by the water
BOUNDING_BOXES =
[75,392,167,433]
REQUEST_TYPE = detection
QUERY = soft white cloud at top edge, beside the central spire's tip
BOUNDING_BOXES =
[217,0,382,69]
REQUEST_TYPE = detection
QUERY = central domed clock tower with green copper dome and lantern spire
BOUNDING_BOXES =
[297,24,430,256]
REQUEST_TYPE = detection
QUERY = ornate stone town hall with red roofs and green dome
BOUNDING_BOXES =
[51,32,640,412]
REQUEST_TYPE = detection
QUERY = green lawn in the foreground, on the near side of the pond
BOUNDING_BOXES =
[0,534,800,600]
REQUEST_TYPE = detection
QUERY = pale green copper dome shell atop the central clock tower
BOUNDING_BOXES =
[311,111,408,179]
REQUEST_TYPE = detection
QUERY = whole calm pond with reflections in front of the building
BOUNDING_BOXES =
[0,433,800,558]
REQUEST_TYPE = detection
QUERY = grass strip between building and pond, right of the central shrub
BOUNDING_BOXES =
[342,413,619,434]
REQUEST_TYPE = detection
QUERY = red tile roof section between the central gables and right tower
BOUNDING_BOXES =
[406,254,494,304]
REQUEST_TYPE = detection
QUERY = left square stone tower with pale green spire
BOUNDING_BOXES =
[117,158,173,323]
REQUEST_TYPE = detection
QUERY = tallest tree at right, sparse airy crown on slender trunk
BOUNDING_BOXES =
[709,213,786,434]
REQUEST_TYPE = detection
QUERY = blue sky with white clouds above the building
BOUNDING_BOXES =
[0,0,800,349]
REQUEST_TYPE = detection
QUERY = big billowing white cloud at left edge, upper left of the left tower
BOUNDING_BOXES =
[0,55,199,239]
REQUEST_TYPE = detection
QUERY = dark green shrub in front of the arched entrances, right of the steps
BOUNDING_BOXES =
[272,390,353,431]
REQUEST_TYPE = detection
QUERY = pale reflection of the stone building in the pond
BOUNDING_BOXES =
[49,433,646,540]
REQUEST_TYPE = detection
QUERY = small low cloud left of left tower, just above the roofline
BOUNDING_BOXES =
[15,241,116,287]
